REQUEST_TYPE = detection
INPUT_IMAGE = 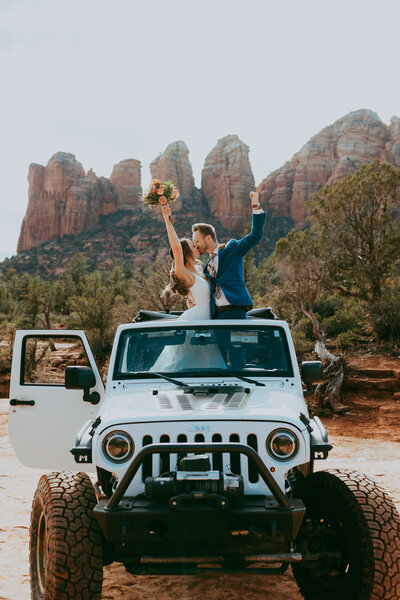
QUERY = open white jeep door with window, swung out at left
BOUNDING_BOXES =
[9,329,104,471]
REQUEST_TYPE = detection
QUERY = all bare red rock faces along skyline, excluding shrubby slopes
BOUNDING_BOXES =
[18,110,400,252]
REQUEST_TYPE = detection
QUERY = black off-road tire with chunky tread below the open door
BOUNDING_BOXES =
[29,473,103,600]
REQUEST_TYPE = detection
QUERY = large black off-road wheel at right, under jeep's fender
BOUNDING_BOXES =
[292,470,400,600]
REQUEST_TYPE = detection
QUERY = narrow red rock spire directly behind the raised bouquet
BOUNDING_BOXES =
[150,141,194,211]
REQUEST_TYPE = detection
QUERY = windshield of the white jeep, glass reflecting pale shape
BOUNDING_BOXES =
[114,323,293,379]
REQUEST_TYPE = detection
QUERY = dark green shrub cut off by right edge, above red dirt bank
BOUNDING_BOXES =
[371,279,400,343]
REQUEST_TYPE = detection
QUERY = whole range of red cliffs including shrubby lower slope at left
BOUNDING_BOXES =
[7,109,400,275]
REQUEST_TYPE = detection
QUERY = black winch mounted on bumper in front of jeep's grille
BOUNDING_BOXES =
[145,454,244,500]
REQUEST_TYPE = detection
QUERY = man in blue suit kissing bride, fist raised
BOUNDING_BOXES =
[192,192,265,319]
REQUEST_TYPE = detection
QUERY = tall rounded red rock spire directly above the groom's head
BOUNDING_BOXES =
[201,135,254,228]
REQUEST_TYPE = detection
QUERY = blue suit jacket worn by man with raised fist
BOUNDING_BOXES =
[203,213,265,317]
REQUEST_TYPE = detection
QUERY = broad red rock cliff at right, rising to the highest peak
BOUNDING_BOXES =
[257,109,400,227]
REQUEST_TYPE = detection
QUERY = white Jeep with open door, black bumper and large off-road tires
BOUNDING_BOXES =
[9,309,400,600]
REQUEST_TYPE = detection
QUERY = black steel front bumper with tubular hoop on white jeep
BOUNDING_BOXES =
[94,442,305,565]
